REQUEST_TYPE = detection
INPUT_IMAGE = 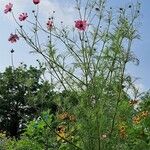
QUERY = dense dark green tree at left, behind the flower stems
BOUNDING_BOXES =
[0,65,56,138]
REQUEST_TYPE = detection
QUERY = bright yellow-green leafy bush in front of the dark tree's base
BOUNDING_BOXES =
[5,111,56,150]
